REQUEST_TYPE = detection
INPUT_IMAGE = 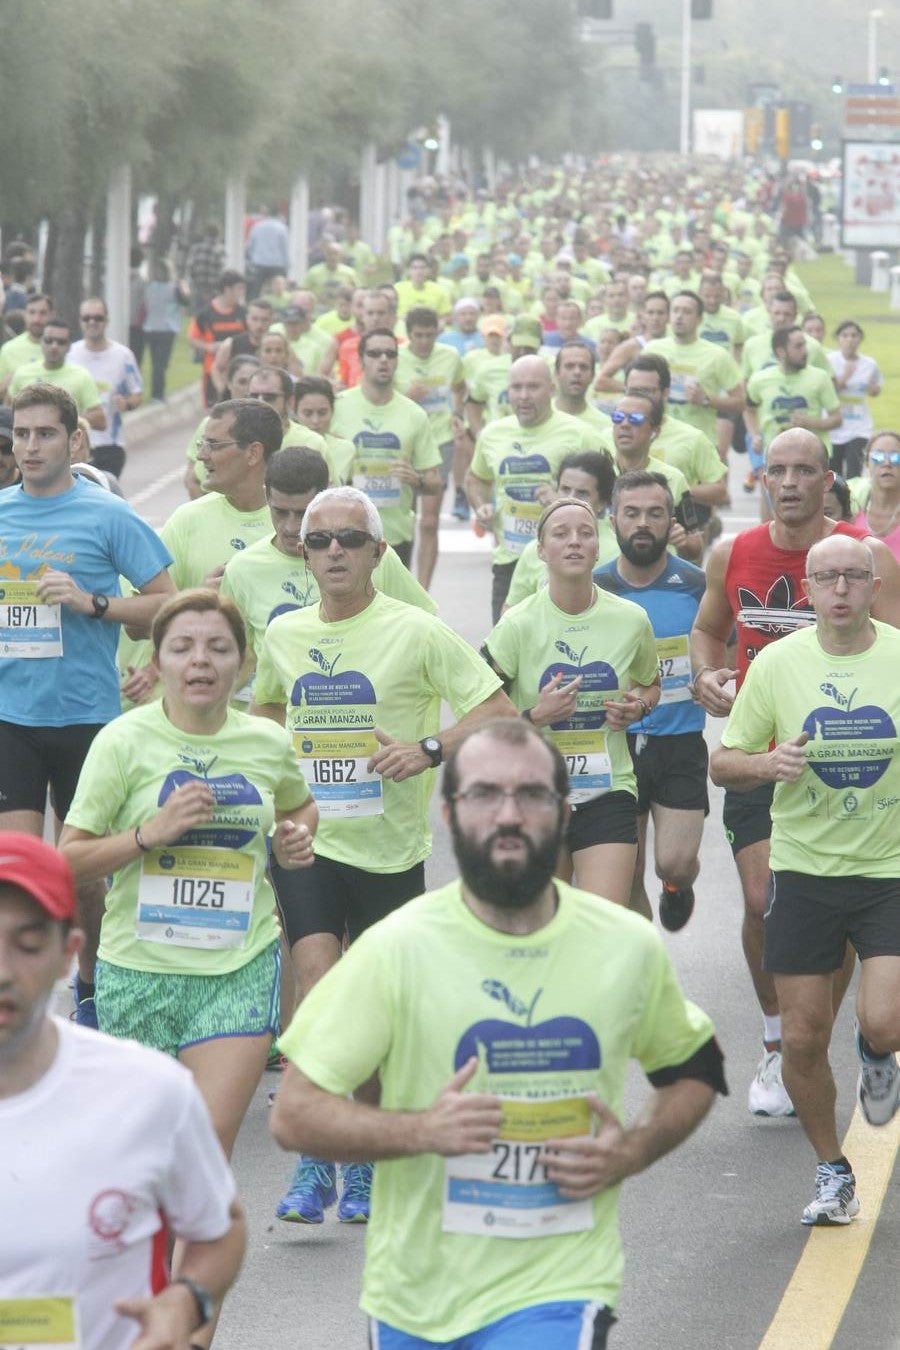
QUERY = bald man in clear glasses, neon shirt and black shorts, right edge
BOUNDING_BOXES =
[711,532,900,1226]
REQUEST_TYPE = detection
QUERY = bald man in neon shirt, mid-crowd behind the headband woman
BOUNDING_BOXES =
[466,356,599,622]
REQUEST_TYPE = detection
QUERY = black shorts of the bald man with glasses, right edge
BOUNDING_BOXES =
[762,872,900,975]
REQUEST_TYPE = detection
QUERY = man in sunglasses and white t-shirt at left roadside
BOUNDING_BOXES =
[69,296,144,478]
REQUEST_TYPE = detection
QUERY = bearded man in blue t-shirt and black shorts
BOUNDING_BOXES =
[594,470,710,933]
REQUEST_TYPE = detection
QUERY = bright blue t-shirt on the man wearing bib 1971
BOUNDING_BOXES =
[0,478,171,726]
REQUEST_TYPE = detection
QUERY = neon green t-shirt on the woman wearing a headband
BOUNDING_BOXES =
[484,586,660,806]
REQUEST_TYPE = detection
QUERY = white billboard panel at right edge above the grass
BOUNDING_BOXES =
[841,140,900,248]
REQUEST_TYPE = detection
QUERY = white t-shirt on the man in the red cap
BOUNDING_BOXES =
[0,1018,235,1350]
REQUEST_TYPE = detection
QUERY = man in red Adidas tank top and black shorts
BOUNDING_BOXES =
[691,427,900,1116]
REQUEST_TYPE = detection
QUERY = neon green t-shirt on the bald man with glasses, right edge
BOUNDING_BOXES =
[722,620,900,878]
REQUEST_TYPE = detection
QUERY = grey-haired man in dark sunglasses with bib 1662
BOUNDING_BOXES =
[254,486,515,1223]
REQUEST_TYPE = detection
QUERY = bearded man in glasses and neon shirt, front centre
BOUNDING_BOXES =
[271,720,727,1350]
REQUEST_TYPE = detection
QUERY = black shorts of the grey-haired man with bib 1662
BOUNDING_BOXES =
[271,856,425,946]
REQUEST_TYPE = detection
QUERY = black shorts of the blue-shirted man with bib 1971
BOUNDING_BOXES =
[0,722,104,821]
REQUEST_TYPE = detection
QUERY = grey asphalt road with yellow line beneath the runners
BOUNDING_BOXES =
[82,412,900,1350]
